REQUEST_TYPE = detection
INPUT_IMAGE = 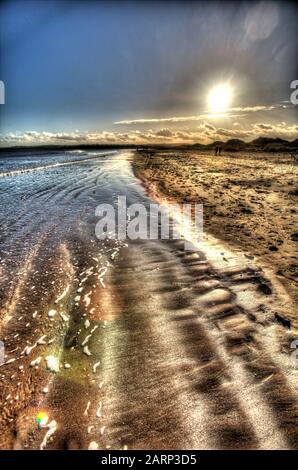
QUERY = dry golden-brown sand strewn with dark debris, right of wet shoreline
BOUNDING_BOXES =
[134,151,298,310]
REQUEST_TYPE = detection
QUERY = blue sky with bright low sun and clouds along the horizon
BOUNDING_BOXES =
[0,0,298,146]
